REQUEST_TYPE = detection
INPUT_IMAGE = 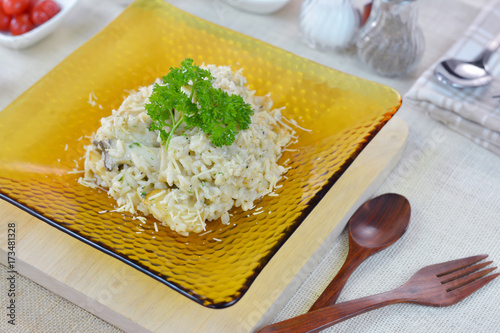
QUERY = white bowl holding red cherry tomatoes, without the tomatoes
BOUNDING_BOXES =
[0,0,78,49]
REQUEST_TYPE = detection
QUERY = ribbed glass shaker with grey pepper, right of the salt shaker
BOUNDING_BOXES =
[356,0,425,76]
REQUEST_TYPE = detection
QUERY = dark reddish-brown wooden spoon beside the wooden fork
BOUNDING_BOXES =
[309,193,411,312]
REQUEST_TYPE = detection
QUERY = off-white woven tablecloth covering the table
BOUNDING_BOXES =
[0,0,500,333]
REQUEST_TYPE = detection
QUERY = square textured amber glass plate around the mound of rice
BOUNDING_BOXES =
[0,0,401,308]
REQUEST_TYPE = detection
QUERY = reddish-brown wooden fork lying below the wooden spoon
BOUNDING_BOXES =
[259,255,500,333]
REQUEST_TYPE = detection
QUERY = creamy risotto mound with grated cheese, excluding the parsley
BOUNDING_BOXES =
[79,60,295,236]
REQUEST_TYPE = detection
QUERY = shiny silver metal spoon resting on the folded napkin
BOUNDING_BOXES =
[434,35,500,88]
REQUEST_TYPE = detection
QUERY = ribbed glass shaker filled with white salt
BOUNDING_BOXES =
[299,0,361,50]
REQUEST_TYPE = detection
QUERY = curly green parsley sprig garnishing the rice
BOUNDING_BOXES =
[146,58,253,149]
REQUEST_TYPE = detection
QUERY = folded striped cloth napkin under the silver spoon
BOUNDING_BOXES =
[406,0,500,155]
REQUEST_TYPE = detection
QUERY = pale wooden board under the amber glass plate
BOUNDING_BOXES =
[0,117,408,333]
